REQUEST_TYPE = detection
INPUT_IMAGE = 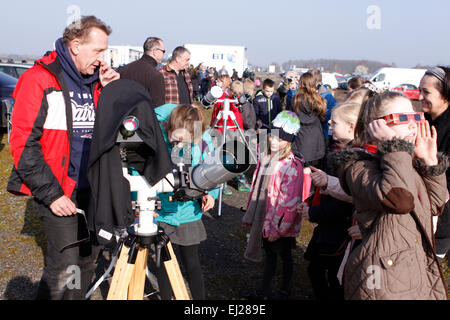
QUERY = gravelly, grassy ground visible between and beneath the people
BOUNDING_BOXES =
[0,79,446,300]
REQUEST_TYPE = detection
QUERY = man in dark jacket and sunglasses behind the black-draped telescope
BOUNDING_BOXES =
[120,37,166,108]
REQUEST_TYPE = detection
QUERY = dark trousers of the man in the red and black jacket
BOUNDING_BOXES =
[34,189,102,300]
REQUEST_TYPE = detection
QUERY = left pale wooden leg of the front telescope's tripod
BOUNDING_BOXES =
[106,245,134,300]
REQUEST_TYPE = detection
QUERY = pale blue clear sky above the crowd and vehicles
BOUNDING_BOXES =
[0,0,450,67]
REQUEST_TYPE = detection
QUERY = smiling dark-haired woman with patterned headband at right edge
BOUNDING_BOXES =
[419,67,450,258]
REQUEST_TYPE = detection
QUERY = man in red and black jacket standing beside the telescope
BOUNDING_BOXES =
[7,16,119,299]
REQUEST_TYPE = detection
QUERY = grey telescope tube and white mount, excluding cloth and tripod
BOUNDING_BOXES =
[117,116,250,237]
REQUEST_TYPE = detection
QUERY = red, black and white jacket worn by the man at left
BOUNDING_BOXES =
[7,51,101,205]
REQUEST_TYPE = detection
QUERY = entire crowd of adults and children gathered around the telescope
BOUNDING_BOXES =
[7,16,450,300]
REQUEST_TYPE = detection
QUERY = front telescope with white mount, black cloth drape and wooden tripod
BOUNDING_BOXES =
[86,79,250,299]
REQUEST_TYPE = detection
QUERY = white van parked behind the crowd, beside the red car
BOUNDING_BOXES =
[370,68,427,89]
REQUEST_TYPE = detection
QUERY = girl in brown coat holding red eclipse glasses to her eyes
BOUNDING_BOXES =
[332,92,448,300]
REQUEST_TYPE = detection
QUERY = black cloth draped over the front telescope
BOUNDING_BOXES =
[88,79,173,244]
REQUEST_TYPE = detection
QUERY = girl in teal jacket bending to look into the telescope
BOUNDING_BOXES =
[155,104,219,300]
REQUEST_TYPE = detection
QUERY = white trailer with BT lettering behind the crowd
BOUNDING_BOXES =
[184,43,248,76]
